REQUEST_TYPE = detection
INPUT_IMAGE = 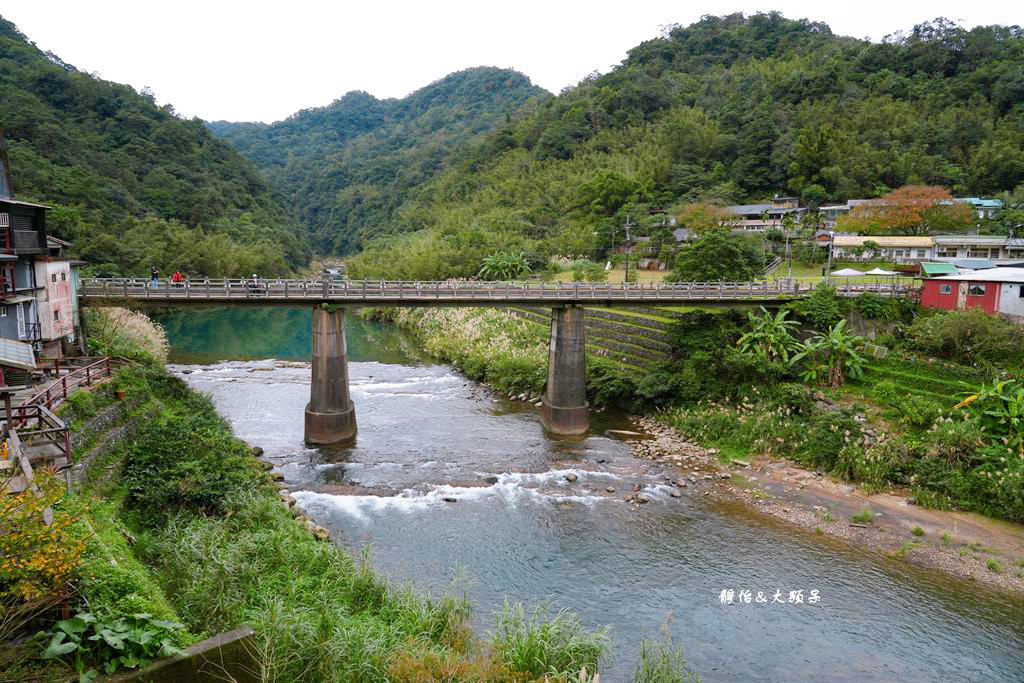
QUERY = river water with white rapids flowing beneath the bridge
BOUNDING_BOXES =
[161,308,1024,681]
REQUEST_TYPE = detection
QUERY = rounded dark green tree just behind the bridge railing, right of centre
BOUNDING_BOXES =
[672,230,764,283]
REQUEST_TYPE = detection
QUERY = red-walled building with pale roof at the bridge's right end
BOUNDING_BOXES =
[921,268,1024,317]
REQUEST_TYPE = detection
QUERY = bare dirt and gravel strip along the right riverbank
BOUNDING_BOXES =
[630,418,1024,595]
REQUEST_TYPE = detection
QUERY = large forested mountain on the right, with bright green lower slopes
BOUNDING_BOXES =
[342,13,1024,279]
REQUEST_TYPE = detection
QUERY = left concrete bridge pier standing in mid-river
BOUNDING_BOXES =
[305,305,355,445]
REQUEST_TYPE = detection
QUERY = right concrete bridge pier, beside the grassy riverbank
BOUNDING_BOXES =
[541,306,590,435]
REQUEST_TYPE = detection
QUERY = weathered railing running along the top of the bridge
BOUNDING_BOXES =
[80,278,906,302]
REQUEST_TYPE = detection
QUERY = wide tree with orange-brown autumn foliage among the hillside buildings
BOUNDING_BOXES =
[838,185,974,234]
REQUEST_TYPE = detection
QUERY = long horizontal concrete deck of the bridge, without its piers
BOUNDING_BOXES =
[79,279,912,306]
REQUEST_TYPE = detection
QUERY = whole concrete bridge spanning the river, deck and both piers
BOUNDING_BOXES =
[78,278,914,445]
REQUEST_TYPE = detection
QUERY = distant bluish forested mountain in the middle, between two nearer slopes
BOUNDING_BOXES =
[203,67,550,254]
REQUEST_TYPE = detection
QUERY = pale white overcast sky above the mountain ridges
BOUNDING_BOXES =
[0,0,1022,122]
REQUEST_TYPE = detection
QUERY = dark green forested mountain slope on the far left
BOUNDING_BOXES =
[0,18,310,275]
